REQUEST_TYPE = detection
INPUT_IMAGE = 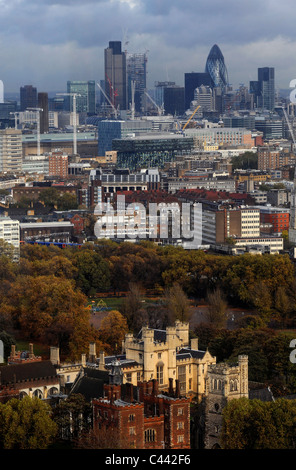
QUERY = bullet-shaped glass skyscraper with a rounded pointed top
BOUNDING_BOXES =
[205,44,229,93]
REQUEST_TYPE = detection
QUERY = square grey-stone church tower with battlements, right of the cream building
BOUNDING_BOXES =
[205,355,249,449]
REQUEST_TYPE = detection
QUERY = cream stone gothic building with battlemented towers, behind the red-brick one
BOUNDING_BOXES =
[90,321,216,401]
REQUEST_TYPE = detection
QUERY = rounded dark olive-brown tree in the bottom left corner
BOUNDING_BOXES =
[0,397,57,449]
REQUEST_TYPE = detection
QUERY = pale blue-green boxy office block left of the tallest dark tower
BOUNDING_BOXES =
[67,80,96,115]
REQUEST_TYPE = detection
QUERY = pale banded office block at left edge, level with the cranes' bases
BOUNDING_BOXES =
[0,129,22,172]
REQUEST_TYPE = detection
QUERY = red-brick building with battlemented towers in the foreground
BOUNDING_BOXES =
[92,376,190,449]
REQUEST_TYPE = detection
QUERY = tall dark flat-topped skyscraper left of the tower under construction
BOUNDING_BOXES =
[104,41,128,110]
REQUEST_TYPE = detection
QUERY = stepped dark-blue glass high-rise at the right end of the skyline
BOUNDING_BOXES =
[250,67,275,111]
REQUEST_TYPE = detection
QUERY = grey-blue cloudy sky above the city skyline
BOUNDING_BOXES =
[0,0,296,92]
